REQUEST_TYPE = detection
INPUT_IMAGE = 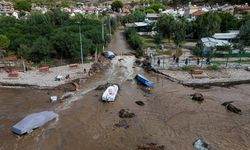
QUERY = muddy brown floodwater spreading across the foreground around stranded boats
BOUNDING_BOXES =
[0,31,250,150]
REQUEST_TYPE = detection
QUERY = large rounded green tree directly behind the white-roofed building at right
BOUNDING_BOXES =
[195,12,221,38]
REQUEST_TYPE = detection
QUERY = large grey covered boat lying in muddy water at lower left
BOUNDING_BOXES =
[11,111,58,135]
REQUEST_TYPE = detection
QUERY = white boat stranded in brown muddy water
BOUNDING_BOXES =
[102,85,119,102]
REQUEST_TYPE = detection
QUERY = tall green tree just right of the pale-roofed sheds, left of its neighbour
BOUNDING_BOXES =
[156,15,175,39]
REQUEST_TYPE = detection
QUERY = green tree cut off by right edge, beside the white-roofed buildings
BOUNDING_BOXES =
[240,20,250,46]
